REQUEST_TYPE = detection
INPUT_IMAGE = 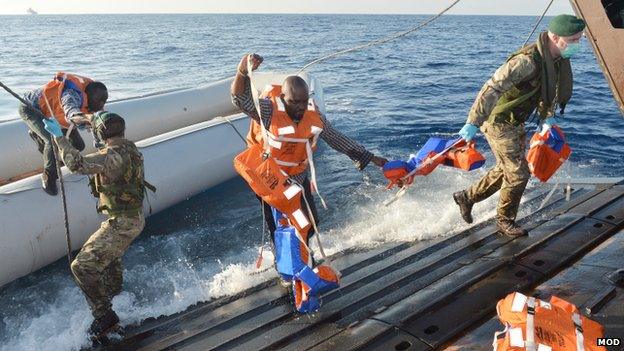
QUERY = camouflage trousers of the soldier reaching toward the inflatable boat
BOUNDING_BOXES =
[71,215,145,319]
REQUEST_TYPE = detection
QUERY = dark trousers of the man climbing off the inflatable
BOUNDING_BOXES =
[18,105,85,178]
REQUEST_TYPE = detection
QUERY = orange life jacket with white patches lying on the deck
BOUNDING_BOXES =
[493,292,606,351]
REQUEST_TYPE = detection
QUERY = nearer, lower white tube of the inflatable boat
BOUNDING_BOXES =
[0,75,324,286]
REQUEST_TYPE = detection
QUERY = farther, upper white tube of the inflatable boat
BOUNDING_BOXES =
[0,73,326,184]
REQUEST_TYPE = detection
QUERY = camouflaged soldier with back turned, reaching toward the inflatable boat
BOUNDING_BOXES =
[44,112,153,339]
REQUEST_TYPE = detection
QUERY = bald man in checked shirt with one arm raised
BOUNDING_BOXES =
[231,54,387,262]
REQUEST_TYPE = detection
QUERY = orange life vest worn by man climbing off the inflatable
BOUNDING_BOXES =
[39,72,93,128]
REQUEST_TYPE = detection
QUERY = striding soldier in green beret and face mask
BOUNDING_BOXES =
[453,15,585,236]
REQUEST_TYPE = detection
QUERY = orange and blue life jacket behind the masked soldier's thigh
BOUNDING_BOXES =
[527,125,572,182]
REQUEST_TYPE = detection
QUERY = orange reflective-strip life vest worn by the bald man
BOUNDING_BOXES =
[247,85,323,175]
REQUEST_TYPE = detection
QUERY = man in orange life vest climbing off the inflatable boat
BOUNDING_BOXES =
[18,72,108,196]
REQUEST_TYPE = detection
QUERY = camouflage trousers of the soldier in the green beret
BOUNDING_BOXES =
[466,122,531,220]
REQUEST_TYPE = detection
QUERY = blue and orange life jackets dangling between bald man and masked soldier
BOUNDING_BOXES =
[383,137,485,189]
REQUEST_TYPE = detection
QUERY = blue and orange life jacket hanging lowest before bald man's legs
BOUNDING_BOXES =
[273,209,339,313]
